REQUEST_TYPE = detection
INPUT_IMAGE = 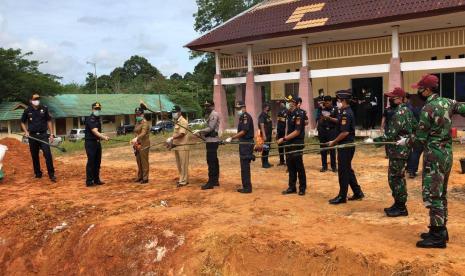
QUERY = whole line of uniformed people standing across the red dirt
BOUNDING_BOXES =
[22,75,465,248]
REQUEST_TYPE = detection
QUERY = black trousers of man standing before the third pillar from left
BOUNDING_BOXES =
[286,147,307,192]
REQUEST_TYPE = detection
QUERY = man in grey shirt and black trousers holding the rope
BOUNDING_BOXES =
[194,101,220,190]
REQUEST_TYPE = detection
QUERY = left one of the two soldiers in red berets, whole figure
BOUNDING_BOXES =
[375,87,417,217]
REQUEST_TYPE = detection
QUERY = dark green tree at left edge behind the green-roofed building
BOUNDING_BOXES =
[0,48,60,102]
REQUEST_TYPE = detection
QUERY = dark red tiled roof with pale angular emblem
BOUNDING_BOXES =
[186,0,465,50]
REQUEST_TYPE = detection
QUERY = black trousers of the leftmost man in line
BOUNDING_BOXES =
[29,133,55,177]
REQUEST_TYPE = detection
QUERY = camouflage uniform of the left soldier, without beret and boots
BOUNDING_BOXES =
[375,104,417,204]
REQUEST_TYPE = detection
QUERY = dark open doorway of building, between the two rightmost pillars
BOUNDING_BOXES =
[352,77,384,126]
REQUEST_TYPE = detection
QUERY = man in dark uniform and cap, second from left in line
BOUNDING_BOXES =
[84,102,109,187]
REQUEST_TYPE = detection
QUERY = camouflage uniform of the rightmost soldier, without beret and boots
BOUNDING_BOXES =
[408,94,465,227]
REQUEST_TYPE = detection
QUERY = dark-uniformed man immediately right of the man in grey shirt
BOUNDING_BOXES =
[225,102,255,194]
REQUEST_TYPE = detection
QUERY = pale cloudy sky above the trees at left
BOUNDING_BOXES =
[0,0,198,83]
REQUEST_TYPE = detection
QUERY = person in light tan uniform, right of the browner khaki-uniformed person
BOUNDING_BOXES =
[166,105,189,188]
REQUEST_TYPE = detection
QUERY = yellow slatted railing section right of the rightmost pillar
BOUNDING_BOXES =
[399,27,465,53]
